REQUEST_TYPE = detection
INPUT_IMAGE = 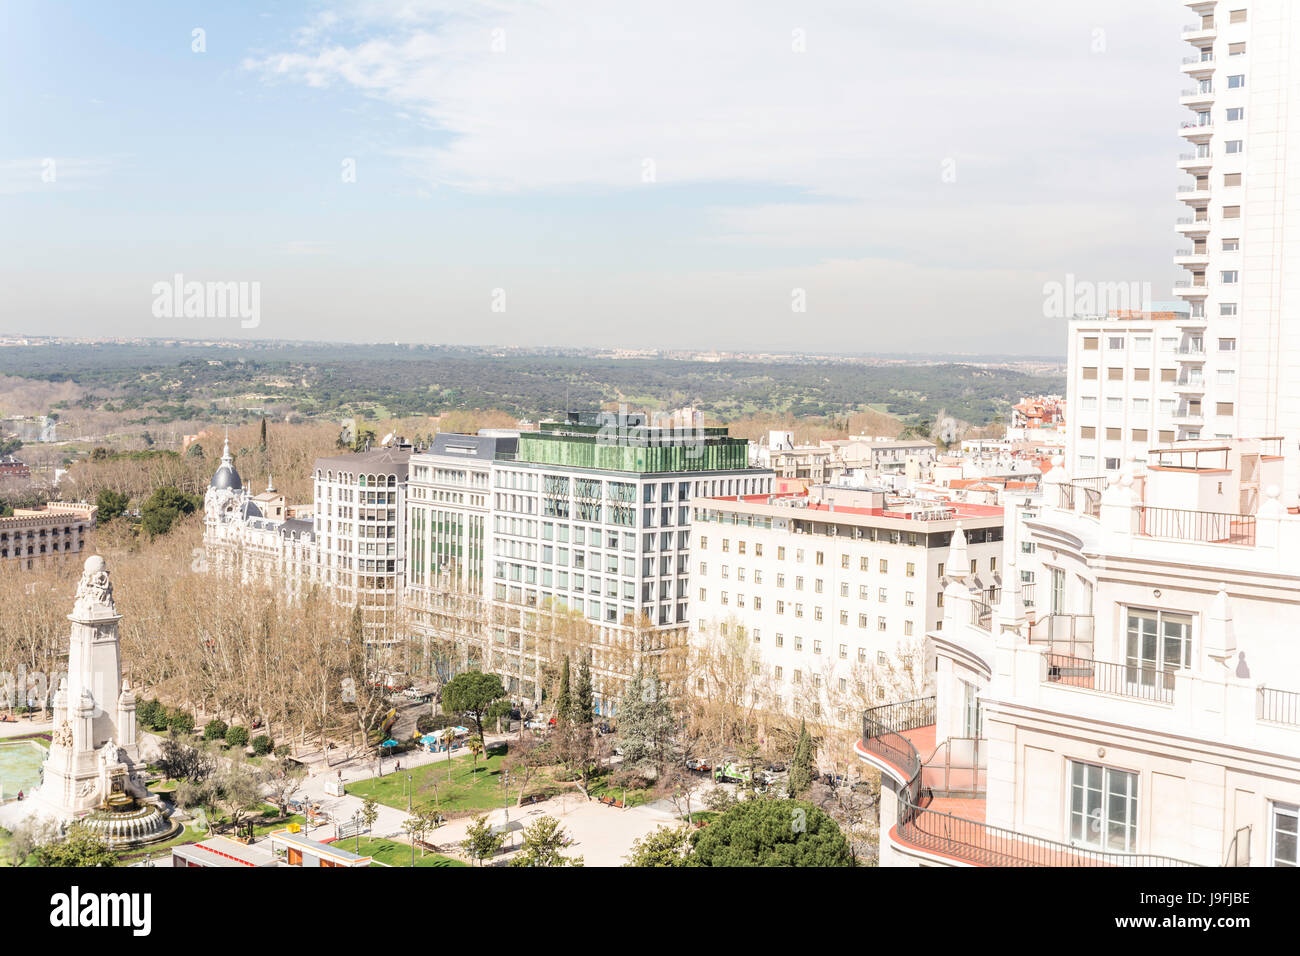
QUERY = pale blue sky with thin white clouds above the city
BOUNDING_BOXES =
[0,0,1191,356]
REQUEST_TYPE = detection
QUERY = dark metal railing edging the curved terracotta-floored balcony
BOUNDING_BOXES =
[862,697,1196,866]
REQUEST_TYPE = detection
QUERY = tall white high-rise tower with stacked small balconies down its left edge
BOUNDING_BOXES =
[1180,0,1300,505]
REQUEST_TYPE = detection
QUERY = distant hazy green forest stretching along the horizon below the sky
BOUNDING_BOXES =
[0,343,1065,425]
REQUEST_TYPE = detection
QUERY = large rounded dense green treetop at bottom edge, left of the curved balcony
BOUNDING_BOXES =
[690,800,853,866]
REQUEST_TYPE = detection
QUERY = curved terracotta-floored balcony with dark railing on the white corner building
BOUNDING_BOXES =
[857,697,1196,866]
